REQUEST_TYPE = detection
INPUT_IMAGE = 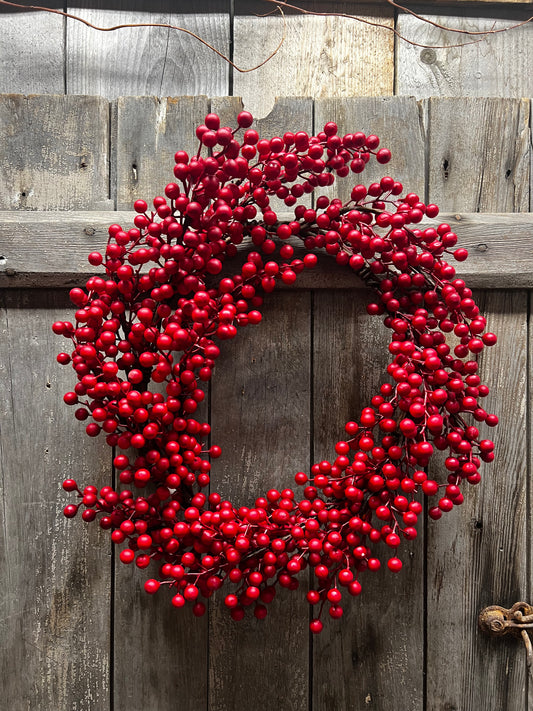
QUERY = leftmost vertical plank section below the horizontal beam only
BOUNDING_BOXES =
[0,290,110,711]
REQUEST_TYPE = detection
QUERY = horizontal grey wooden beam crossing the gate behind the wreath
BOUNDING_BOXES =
[0,211,533,289]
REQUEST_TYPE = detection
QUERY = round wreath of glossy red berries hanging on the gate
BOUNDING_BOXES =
[53,112,497,633]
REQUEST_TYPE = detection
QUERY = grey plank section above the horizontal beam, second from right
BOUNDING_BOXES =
[315,96,425,200]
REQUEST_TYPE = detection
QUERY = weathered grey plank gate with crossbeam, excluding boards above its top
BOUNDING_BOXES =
[0,95,533,711]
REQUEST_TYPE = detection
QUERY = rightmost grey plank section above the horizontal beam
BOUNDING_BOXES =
[429,98,531,212]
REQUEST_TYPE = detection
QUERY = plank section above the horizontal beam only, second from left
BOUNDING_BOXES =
[116,96,209,210]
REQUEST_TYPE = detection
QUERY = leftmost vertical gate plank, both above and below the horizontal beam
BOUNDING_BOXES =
[0,90,111,711]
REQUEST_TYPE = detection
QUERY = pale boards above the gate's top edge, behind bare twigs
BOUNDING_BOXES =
[0,0,533,116]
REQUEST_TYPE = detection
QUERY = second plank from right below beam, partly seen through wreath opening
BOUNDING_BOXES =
[313,290,424,711]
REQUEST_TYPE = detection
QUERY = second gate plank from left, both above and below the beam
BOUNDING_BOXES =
[112,97,209,711]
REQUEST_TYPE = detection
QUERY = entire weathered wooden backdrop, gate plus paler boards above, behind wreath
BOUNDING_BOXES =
[0,0,533,711]
